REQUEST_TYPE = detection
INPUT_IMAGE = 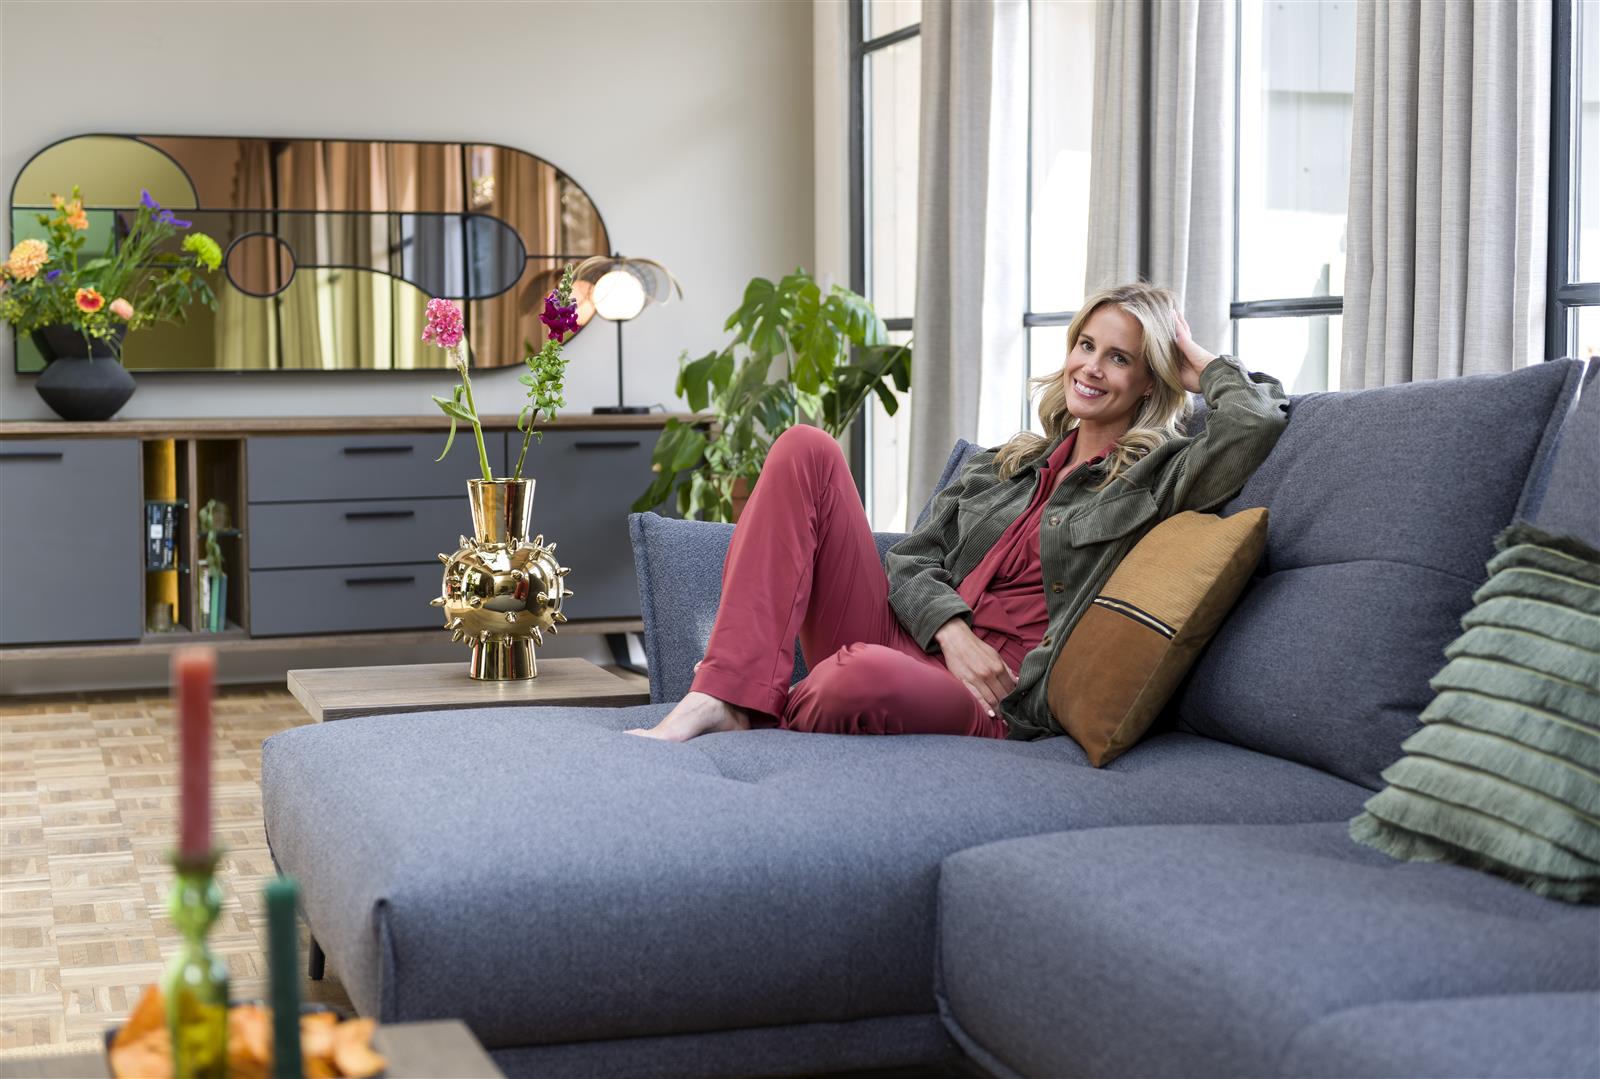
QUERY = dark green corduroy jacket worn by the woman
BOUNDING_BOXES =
[888,355,1290,738]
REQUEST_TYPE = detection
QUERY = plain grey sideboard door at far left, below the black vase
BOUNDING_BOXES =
[0,439,144,645]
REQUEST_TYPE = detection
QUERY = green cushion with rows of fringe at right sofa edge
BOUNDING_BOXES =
[1350,525,1600,903]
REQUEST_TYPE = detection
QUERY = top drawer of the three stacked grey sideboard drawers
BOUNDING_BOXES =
[246,427,506,503]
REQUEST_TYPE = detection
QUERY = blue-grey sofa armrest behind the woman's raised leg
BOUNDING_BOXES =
[627,514,902,703]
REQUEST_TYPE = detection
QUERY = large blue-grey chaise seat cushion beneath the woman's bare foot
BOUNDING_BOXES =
[262,704,1365,1065]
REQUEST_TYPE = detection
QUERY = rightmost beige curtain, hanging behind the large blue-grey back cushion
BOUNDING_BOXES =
[1341,0,1550,389]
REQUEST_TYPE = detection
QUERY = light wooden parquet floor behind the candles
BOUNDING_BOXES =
[0,687,349,1052]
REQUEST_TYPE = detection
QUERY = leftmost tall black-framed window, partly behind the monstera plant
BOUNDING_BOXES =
[850,0,922,530]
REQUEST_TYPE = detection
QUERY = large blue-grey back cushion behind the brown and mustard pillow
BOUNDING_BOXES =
[1178,362,1581,789]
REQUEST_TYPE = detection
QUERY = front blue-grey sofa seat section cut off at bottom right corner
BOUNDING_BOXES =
[1278,993,1600,1079]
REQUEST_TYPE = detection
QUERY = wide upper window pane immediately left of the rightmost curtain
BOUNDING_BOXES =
[1237,0,1355,299]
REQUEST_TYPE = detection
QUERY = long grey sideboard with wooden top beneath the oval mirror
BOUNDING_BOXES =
[0,413,688,661]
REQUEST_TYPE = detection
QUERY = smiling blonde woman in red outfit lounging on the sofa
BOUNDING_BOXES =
[632,283,1288,741]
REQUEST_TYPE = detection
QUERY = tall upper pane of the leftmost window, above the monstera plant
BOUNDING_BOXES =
[866,37,922,319]
